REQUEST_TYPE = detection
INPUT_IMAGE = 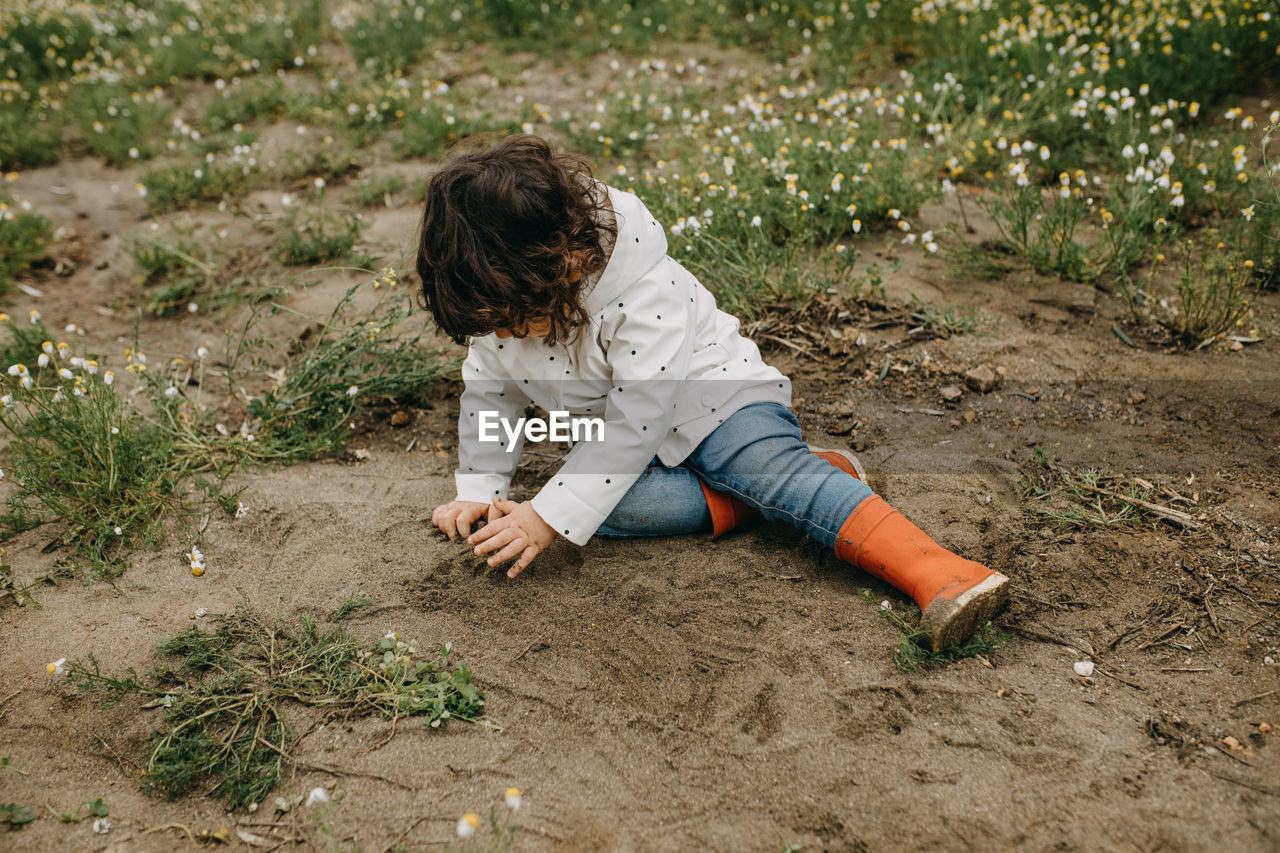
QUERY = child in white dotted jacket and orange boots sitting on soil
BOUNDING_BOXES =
[417,136,1007,651]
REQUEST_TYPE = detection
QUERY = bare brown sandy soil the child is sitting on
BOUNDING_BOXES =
[0,54,1280,850]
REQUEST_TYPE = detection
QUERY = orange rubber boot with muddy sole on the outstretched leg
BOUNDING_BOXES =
[836,496,1009,652]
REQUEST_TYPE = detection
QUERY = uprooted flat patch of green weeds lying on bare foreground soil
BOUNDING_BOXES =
[68,606,486,808]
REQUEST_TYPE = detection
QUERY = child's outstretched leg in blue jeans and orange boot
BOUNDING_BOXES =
[686,403,1009,651]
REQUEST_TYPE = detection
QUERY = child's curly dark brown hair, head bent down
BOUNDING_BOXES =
[417,136,617,345]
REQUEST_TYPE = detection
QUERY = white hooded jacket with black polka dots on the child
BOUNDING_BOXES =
[456,187,791,544]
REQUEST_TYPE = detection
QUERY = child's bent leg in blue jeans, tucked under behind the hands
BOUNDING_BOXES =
[596,459,712,537]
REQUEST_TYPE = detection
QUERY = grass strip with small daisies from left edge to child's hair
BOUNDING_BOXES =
[0,270,457,578]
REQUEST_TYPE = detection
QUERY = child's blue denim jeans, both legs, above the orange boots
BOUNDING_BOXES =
[596,402,873,548]
